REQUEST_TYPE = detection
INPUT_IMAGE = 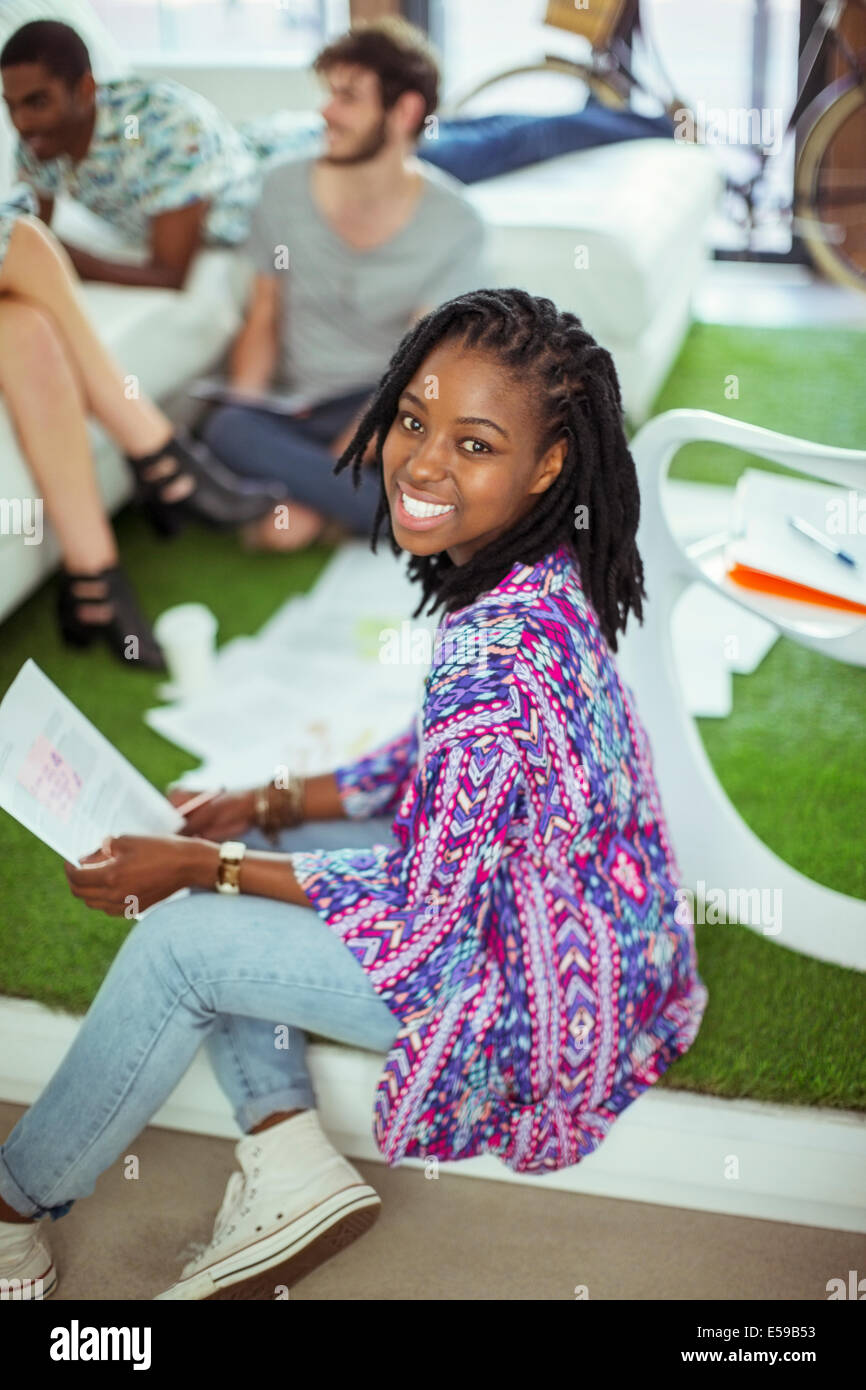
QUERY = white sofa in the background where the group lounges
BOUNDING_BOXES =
[0,19,719,620]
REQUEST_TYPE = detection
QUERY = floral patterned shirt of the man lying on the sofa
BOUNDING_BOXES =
[15,78,320,246]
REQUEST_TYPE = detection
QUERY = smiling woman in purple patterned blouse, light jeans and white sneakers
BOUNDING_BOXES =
[0,289,708,1300]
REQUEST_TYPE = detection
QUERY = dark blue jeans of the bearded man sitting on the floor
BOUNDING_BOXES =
[202,385,381,535]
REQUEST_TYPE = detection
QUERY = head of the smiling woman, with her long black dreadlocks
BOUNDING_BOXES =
[335,291,644,651]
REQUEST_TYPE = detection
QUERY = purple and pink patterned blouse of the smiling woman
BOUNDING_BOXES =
[292,546,708,1173]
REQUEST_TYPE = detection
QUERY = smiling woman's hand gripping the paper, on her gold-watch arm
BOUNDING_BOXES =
[64,828,220,917]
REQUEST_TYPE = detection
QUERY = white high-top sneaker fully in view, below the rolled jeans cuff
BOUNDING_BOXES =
[156,1111,382,1300]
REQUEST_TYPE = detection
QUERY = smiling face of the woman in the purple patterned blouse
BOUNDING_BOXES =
[382,341,566,564]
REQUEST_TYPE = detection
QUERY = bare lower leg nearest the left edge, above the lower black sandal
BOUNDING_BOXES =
[0,297,117,592]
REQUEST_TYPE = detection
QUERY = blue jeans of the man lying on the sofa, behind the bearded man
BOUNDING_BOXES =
[416,97,674,183]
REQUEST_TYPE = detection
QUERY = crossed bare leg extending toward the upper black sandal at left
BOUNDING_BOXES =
[0,217,195,502]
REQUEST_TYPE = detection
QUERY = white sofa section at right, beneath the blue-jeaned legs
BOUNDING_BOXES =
[466,139,720,343]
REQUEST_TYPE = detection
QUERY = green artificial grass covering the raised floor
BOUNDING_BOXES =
[0,324,866,1109]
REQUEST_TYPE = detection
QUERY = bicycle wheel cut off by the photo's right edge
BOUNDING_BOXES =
[794,76,866,292]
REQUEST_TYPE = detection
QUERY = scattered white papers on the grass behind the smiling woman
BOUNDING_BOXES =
[145,543,439,790]
